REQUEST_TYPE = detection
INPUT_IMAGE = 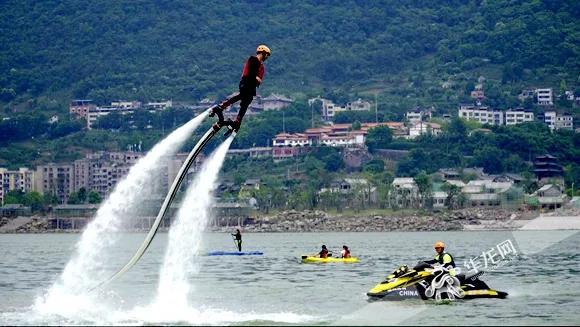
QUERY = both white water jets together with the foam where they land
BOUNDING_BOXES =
[27,114,312,324]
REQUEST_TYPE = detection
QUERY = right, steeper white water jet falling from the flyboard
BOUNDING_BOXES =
[154,135,234,311]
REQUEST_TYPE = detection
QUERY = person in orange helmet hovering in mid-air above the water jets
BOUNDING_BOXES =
[209,44,270,132]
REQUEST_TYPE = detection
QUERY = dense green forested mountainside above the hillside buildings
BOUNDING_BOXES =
[0,0,580,111]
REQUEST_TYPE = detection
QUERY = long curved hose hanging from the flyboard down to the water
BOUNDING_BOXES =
[90,108,231,291]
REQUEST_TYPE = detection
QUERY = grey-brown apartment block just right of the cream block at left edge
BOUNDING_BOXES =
[35,163,74,204]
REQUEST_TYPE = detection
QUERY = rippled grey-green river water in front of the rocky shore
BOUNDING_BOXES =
[0,231,580,325]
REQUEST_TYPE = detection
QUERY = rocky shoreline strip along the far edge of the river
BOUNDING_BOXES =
[0,208,580,233]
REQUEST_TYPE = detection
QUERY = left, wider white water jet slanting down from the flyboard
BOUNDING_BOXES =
[37,111,208,305]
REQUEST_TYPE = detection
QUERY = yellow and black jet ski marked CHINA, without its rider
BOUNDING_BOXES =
[367,263,508,301]
